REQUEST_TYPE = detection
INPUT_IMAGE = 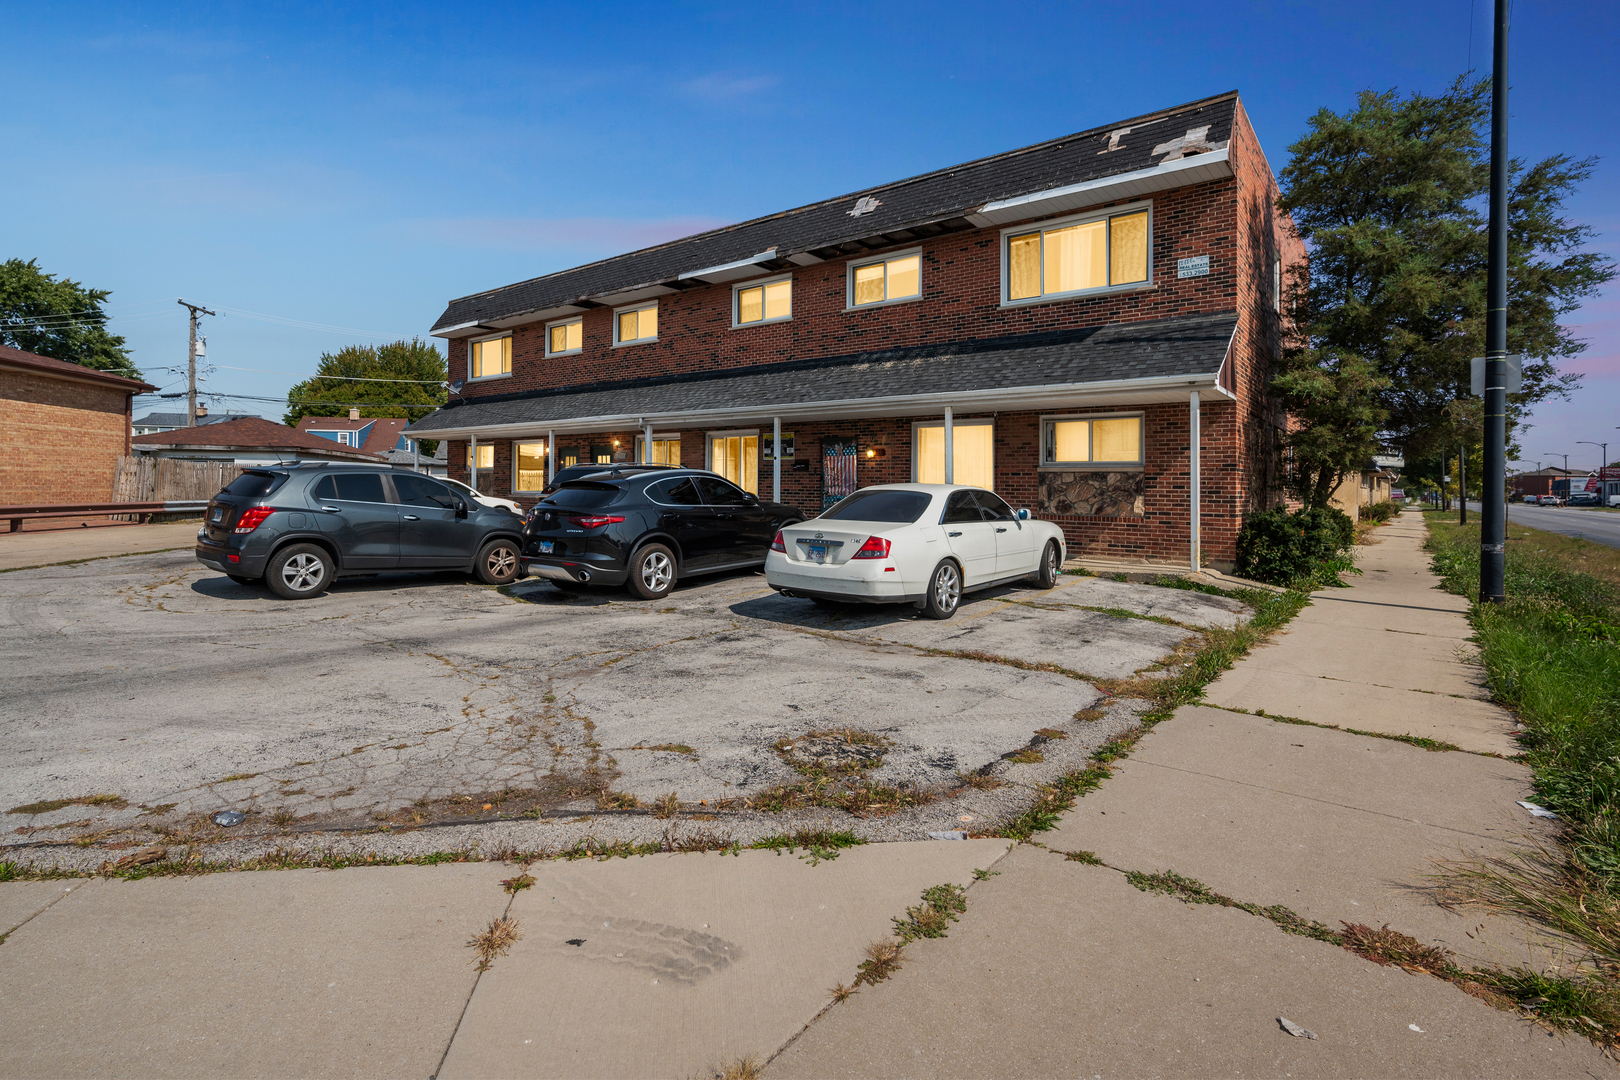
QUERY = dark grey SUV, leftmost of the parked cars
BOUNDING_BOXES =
[196,461,523,599]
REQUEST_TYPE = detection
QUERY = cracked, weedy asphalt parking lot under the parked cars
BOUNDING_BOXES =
[0,551,1244,865]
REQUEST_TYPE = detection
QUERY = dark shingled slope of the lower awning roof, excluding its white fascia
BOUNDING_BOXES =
[410,313,1238,436]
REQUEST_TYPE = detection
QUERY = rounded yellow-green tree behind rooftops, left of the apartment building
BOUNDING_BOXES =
[284,338,447,437]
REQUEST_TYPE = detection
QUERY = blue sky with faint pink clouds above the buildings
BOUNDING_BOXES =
[0,0,1620,465]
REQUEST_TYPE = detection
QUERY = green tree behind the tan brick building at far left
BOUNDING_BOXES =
[0,259,141,379]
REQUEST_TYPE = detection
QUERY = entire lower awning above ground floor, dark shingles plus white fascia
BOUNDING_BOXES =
[408,313,1238,437]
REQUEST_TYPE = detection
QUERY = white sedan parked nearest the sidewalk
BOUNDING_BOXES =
[765,484,1066,619]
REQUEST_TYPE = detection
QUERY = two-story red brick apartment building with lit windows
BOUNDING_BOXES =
[408,92,1304,565]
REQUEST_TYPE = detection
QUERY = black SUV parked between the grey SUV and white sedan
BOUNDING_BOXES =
[523,468,805,601]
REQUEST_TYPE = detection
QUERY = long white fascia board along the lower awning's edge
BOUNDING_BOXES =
[402,372,1234,439]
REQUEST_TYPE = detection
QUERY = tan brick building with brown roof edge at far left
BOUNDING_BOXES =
[0,345,157,505]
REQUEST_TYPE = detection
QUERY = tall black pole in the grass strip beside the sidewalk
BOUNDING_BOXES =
[1479,0,1510,604]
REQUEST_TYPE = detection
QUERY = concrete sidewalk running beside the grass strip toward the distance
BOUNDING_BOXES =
[766,515,1615,1077]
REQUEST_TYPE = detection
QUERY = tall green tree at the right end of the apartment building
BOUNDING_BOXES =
[1273,78,1615,504]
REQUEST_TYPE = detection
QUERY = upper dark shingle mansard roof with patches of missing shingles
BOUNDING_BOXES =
[433,91,1238,330]
